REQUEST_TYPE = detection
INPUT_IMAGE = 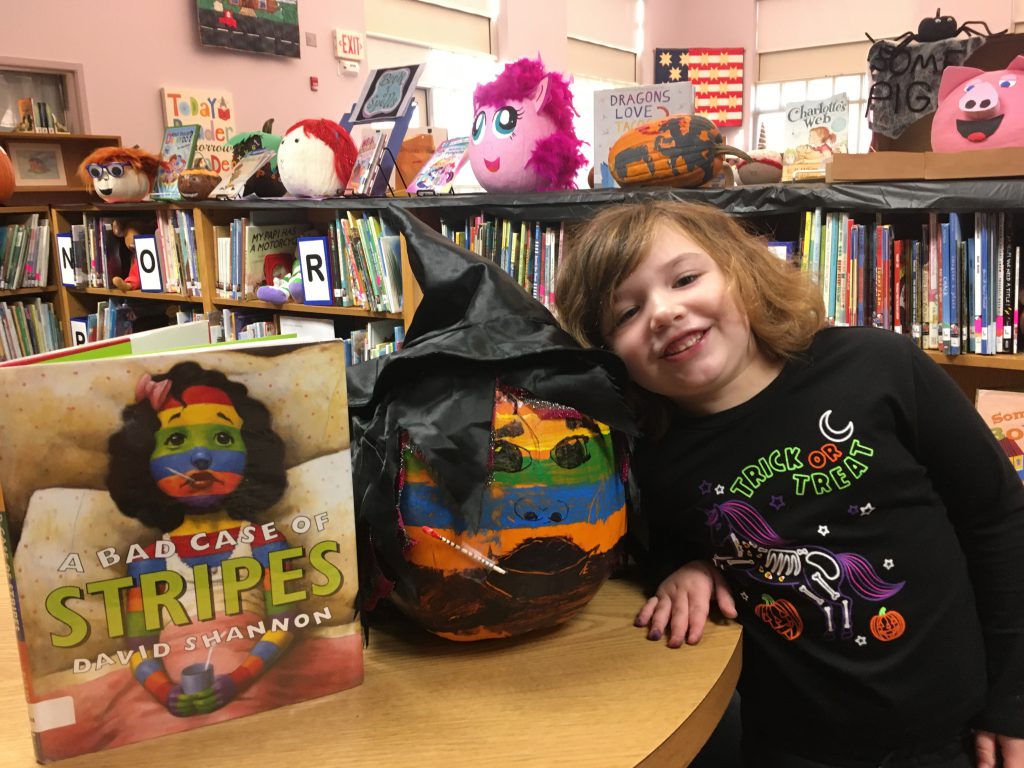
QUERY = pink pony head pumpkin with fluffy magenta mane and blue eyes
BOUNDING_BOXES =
[469,58,587,193]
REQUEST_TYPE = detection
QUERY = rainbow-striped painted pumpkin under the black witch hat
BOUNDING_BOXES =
[392,385,626,640]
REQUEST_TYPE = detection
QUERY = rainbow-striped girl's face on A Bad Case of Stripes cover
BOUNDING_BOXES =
[150,386,246,507]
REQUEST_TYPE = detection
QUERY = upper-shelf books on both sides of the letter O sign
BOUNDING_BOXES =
[64,210,201,296]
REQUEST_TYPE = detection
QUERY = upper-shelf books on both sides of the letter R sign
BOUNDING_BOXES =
[213,211,402,312]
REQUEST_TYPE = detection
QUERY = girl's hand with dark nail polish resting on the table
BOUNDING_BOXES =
[634,560,736,648]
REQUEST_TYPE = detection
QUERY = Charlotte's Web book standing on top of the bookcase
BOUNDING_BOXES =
[782,93,850,181]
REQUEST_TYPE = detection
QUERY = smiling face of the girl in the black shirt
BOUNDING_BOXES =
[602,223,781,414]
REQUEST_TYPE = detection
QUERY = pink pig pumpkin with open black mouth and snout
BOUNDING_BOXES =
[932,56,1024,152]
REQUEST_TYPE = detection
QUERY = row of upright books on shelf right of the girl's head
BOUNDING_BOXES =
[796,209,1020,355]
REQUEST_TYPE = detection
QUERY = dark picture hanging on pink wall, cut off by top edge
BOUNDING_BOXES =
[196,0,299,58]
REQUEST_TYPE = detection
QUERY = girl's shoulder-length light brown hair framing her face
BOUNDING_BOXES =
[555,201,825,360]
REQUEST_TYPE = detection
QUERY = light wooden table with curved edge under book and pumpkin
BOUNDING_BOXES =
[0,568,740,768]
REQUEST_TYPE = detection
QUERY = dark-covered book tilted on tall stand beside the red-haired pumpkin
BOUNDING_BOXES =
[339,63,425,197]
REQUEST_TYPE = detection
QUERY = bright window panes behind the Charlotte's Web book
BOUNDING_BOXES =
[751,74,871,153]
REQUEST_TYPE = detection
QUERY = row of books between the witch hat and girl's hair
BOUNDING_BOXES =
[441,215,565,307]
